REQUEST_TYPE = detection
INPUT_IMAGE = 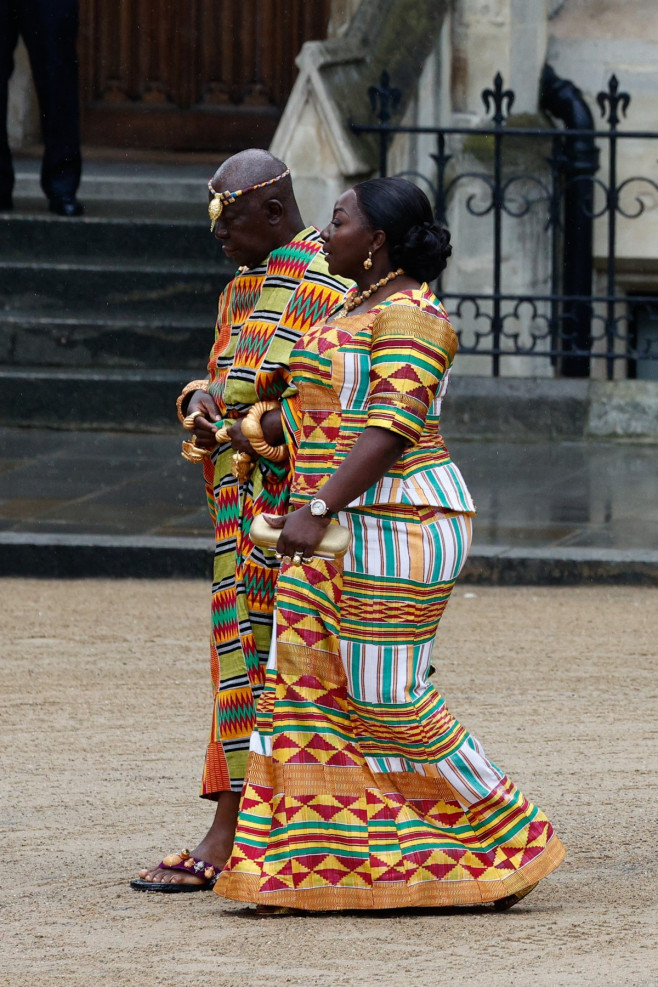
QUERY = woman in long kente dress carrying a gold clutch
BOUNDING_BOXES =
[215,179,565,912]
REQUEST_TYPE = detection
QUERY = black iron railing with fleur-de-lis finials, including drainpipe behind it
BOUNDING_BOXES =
[350,68,658,379]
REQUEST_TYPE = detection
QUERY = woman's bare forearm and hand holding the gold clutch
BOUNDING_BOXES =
[268,426,407,557]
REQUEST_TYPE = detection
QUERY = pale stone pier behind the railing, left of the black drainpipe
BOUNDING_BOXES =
[390,0,553,377]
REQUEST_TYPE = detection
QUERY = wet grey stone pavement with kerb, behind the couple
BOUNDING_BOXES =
[0,428,658,582]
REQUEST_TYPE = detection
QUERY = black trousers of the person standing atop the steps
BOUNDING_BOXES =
[0,0,81,200]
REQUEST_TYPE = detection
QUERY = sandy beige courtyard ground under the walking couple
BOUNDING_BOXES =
[0,580,658,987]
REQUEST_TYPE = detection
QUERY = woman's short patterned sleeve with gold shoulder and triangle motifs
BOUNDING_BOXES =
[367,302,457,444]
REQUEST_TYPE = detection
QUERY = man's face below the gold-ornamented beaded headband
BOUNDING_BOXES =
[211,183,272,267]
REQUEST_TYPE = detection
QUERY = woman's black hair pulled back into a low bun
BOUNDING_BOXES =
[354,178,452,281]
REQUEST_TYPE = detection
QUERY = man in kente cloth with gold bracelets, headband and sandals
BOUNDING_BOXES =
[131,149,349,892]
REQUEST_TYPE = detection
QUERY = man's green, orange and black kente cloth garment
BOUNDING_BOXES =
[202,229,346,797]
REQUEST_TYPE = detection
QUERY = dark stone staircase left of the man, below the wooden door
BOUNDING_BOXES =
[0,162,233,431]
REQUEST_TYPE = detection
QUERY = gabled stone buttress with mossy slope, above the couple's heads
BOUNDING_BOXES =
[271,0,450,225]
